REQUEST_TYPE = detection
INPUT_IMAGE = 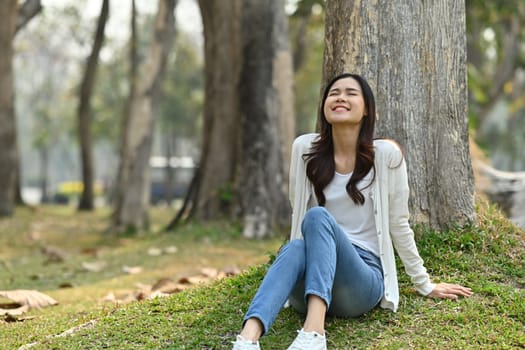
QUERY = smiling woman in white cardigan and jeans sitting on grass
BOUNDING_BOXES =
[233,73,472,349]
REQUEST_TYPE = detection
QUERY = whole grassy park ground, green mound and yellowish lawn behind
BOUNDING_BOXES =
[0,200,525,349]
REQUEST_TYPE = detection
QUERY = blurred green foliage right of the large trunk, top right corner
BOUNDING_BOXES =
[466,0,525,171]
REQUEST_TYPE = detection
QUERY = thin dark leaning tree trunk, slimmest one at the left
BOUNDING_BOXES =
[78,0,109,210]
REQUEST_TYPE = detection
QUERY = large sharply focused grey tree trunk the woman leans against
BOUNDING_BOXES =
[323,0,475,228]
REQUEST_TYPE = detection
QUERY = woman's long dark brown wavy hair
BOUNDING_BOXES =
[303,73,376,206]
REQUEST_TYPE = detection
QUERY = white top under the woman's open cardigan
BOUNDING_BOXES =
[323,170,379,256]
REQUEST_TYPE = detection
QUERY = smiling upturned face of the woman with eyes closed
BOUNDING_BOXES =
[323,77,366,126]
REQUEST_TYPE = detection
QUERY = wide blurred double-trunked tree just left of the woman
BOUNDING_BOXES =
[168,0,295,237]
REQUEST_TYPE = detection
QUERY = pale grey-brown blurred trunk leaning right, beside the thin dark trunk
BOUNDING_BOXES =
[113,0,176,229]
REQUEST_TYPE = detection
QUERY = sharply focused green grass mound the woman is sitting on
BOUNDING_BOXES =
[0,201,525,349]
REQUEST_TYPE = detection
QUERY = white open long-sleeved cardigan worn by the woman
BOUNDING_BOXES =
[290,134,434,311]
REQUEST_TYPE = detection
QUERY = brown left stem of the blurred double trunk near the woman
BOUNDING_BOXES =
[193,0,241,220]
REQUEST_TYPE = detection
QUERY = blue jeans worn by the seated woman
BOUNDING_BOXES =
[244,207,384,333]
